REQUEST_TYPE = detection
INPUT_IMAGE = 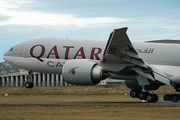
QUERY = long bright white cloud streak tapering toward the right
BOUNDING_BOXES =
[0,9,125,27]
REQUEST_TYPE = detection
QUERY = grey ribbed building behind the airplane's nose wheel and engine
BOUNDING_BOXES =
[0,62,124,87]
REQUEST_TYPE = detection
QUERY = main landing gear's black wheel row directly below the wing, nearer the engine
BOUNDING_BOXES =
[130,90,159,102]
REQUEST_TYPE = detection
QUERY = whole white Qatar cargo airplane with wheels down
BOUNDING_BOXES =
[3,27,180,102]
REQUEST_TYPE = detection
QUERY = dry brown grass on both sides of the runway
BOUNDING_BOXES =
[0,85,180,120]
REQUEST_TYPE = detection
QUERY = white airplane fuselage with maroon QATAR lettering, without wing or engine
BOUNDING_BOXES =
[3,38,180,84]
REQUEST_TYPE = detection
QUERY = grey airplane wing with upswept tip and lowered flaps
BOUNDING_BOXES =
[100,28,170,85]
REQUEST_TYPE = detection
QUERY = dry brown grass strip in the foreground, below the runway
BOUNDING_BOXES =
[0,104,180,120]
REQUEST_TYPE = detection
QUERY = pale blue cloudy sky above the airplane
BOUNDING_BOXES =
[0,0,180,62]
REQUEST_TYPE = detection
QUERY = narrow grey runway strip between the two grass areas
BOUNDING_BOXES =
[0,101,180,105]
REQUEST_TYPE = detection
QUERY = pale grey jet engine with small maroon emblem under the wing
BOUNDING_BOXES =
[62,59,109,85]
